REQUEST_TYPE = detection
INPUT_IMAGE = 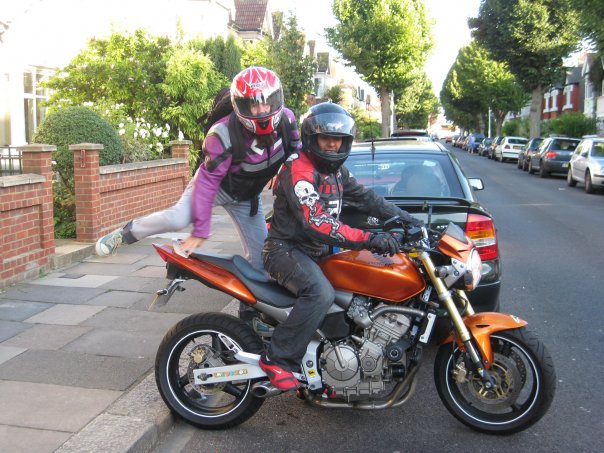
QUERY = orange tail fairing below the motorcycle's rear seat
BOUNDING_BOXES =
[153,244,256,304]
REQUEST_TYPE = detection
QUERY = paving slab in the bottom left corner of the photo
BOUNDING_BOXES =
[0,425,72,453]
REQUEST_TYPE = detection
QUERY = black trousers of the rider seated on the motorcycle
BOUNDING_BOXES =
[262,240,335,371]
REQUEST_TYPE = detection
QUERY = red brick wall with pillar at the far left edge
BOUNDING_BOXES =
[0,145,55,288]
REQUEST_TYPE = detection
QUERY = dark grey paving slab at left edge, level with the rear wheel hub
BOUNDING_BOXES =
[0,350,154,390]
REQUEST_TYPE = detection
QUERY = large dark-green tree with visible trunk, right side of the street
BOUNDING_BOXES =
[468,0,579,137]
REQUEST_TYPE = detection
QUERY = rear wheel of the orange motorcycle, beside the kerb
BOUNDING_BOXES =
[155,313,264,429]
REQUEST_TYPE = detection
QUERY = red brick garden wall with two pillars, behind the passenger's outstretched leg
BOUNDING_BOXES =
[70,141,190,242]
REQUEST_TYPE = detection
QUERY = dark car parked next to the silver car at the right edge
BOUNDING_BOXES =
[528,137,581,178]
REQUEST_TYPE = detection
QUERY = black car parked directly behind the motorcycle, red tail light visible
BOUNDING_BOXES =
[341,139,501,311]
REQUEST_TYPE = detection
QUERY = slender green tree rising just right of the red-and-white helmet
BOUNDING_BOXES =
[268,15,316,117]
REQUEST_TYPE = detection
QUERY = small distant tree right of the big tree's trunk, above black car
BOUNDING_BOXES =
[395,71,439,129]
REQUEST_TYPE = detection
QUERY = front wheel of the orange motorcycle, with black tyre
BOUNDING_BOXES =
[434,327,556,434]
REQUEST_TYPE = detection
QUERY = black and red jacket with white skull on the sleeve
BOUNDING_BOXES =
[268,152,401,256]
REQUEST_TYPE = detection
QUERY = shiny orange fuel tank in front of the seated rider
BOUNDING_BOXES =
[320,250,426,302]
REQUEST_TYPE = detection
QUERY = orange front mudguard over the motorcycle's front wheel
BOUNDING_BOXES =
[443,312,528,368]
